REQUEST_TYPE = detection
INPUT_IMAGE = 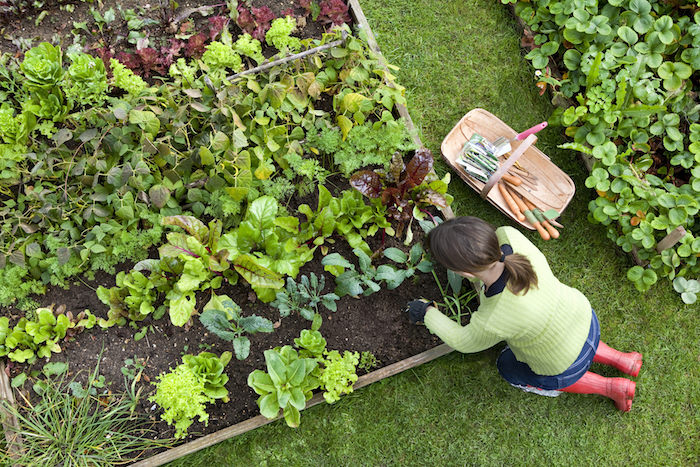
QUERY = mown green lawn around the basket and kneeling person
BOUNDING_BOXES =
[165,0,700,467]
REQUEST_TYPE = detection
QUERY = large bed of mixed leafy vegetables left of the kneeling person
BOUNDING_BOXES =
[0,1,470,460]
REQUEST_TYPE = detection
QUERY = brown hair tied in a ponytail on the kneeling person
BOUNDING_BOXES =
[427,216,537,294]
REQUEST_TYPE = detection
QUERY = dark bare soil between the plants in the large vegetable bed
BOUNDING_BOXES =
[0,175,456,441]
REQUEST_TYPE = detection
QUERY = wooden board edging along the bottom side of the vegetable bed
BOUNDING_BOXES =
[131,344,453,467]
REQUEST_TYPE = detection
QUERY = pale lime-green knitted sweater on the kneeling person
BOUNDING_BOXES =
[424,227,592,375]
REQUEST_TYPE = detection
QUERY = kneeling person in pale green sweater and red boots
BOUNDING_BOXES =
[408,217,642,412]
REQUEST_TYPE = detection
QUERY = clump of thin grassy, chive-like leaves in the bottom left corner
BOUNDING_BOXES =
[0,363,172,467]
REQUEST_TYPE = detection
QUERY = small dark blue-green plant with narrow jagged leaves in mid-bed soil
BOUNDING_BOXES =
[271,272,340,321]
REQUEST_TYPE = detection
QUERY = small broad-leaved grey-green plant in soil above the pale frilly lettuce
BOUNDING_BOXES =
[199,294,274,360]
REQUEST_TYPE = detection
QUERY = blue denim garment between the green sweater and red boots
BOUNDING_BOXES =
[496,310,600,390]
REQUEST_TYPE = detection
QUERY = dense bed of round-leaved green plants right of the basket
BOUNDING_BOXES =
[506,0,700,299]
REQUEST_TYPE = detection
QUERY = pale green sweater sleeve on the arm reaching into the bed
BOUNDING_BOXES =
[423,307,503,353]
